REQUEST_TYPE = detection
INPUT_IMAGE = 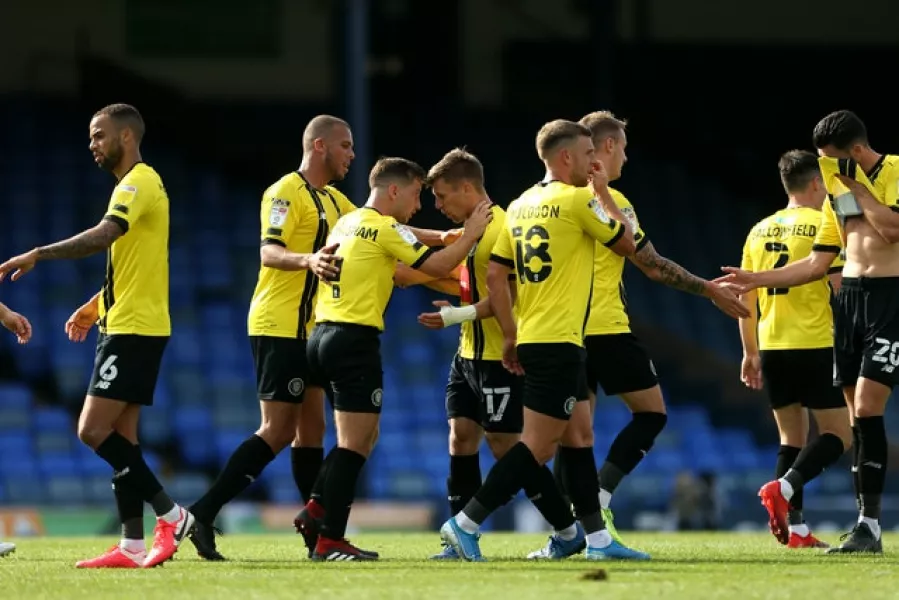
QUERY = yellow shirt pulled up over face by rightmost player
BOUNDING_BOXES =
[814,154,899,252]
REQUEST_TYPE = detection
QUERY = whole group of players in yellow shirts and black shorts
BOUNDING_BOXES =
[0,104,899,568]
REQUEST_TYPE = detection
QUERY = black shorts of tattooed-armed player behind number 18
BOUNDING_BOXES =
[584,333,659,396]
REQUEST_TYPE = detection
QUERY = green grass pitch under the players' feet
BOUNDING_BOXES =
[0,533,899,600]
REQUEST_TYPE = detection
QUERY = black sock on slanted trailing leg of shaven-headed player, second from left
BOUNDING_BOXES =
[190,434,275,525]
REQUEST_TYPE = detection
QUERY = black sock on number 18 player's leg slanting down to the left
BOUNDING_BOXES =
[463,442,541,525]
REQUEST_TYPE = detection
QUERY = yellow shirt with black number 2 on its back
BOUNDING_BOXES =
[741,207,843,350]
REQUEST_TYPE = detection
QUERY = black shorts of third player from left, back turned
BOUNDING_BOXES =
[306,323,384,413]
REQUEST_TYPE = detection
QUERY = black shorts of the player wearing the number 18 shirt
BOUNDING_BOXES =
[518,343,587,421]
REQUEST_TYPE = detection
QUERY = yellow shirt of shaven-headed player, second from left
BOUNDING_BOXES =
[247,171,356,339]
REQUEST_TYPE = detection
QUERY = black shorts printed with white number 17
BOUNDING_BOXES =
[446,354,524,433]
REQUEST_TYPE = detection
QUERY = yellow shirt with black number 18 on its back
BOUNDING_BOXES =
[490,181,624,346]
